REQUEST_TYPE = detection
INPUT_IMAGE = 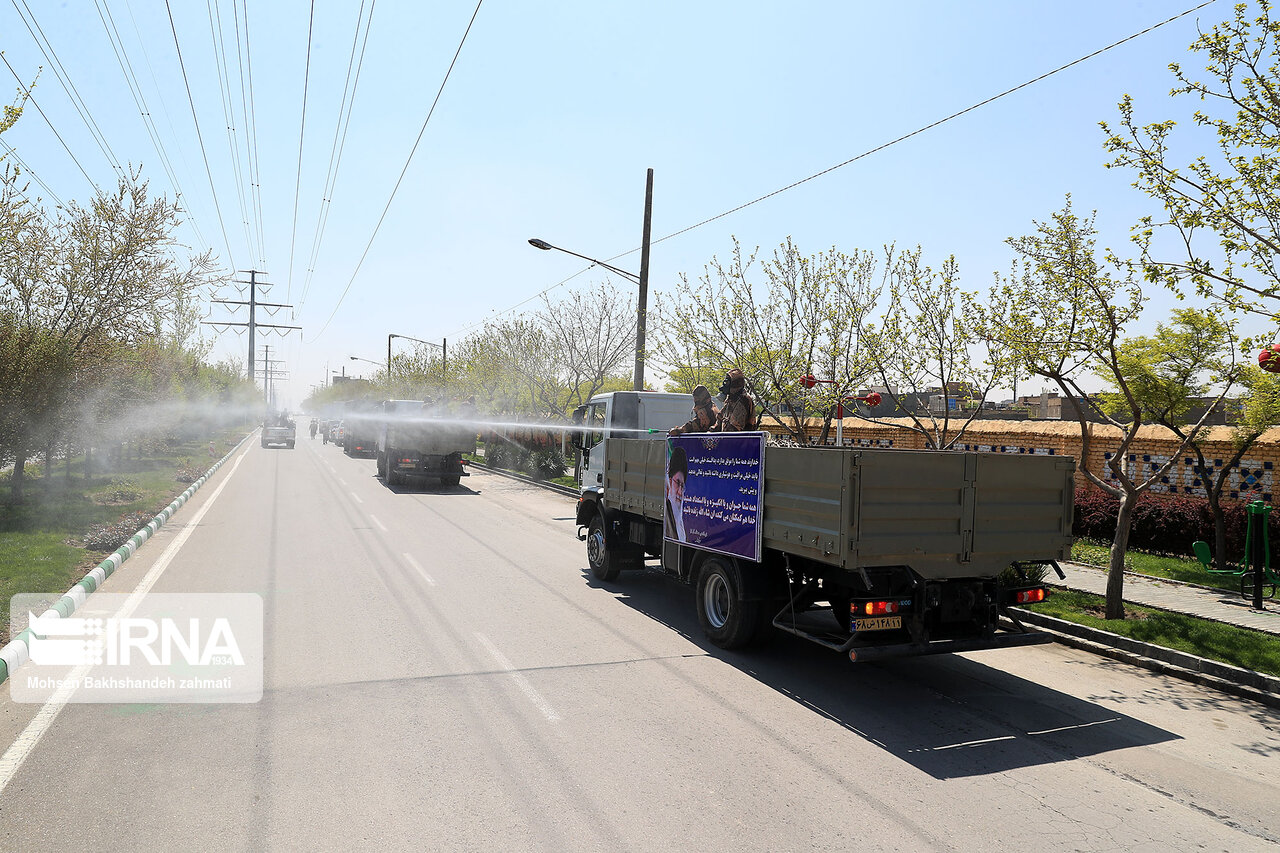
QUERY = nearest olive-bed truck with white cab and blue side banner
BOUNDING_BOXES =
[575,392,1075,661]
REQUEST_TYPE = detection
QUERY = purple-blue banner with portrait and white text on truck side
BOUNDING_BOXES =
[663,433,765,562]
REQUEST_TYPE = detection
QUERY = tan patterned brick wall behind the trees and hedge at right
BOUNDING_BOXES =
[765,418,1280,502]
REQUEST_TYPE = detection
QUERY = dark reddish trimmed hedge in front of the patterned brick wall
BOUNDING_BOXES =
[1071,489,1280,560]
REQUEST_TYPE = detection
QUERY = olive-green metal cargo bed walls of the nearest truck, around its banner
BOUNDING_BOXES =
[604,439,1074,579]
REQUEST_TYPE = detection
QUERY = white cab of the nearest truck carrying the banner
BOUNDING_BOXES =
[573,391,694,488]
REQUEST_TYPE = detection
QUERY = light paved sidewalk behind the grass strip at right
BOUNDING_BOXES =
[1046,562,1280,635]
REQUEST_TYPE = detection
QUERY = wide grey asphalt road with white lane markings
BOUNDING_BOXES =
[0,439,1280,853]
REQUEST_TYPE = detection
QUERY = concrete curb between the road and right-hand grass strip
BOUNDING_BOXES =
[1014,607,1280,708]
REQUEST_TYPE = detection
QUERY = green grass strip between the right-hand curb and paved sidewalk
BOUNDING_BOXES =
[1027,589,1280,676]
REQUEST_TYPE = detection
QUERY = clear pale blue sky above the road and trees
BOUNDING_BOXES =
[0,0,1231,403]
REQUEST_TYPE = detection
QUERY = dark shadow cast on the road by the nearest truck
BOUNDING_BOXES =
[584,563,1180,779]
